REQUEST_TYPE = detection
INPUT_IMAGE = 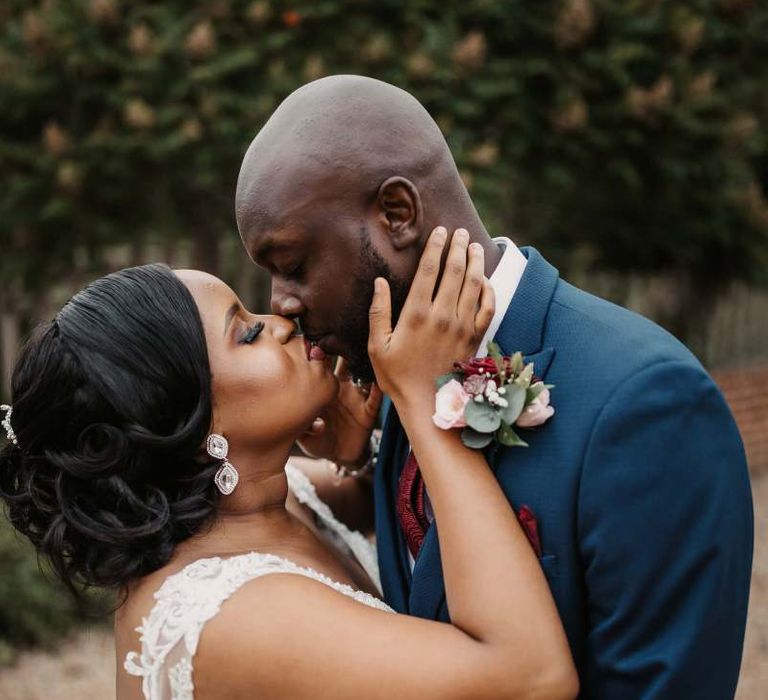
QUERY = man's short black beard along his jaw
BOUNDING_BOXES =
[342,229,410,382]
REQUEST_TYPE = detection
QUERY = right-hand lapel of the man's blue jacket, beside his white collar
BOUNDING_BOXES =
[408,248,559,619]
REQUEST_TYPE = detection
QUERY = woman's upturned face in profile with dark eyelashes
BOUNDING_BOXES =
[177,270,338,449]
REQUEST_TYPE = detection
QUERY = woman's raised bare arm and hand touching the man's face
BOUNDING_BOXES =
[195,230,578,700]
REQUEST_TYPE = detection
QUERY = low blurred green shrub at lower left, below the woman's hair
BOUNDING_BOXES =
[0,513,107,665]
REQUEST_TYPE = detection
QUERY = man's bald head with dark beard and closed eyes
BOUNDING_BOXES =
[236,75,500,380]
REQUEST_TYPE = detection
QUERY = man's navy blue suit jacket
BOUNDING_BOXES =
[375,248,753,700]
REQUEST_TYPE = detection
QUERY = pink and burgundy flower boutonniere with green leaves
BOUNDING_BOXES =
[432,342,555,450]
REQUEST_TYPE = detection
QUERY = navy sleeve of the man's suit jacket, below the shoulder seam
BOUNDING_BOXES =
[578,361,753,700]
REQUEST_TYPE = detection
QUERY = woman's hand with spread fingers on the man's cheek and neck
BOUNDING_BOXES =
[368,226,495,405]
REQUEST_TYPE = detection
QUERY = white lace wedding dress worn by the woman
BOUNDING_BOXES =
[124,464,392,700]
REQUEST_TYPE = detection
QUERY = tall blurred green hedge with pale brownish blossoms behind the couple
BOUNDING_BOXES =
[0,0,768,300]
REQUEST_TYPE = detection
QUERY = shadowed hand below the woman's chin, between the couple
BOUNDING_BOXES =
[299,358,382,467]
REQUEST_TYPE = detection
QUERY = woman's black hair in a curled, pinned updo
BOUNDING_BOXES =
[0,264,217,590]
